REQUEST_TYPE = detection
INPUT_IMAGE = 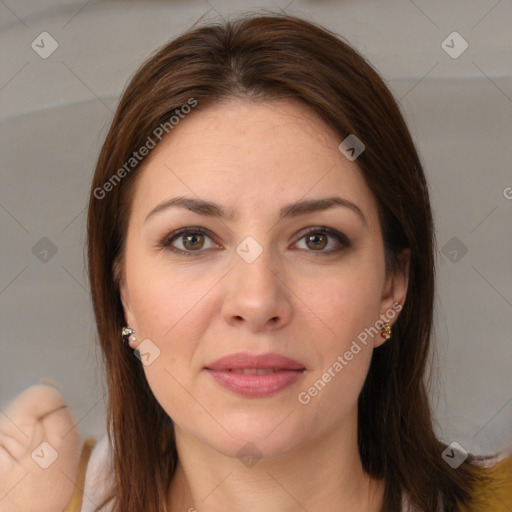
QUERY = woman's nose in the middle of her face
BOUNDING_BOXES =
[222,243,293,332]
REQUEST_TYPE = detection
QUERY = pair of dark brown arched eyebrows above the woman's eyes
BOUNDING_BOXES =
[144,196,368,226]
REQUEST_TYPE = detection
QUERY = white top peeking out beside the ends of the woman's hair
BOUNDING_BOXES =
[80,435,456,512]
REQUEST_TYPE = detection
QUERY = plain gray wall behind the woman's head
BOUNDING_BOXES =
[0,0,512,453]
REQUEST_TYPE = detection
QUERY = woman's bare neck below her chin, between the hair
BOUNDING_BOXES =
[169,408,384,512]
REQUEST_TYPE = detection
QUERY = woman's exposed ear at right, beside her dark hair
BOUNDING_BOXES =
[374,249,411,347]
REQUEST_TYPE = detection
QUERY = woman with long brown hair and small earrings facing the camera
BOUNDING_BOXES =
[2,15,512,512]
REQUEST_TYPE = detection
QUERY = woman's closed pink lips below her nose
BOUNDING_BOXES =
[205,353,305,398]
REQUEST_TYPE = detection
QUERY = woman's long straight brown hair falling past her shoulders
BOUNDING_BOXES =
[88,10,494,512]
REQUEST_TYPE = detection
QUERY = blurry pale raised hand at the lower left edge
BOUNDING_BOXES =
[0,384,81,512]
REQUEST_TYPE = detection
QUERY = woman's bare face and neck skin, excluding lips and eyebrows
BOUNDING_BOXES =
[120,99,407,512]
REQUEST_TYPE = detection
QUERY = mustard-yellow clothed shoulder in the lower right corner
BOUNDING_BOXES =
[460,451,512,512]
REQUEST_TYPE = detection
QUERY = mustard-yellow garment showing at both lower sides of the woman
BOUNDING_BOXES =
[64,438,512,512]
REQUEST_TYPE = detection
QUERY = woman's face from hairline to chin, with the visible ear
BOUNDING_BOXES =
[121,100,407,457]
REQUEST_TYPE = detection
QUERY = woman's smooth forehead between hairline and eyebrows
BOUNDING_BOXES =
[130,99,377,228]
